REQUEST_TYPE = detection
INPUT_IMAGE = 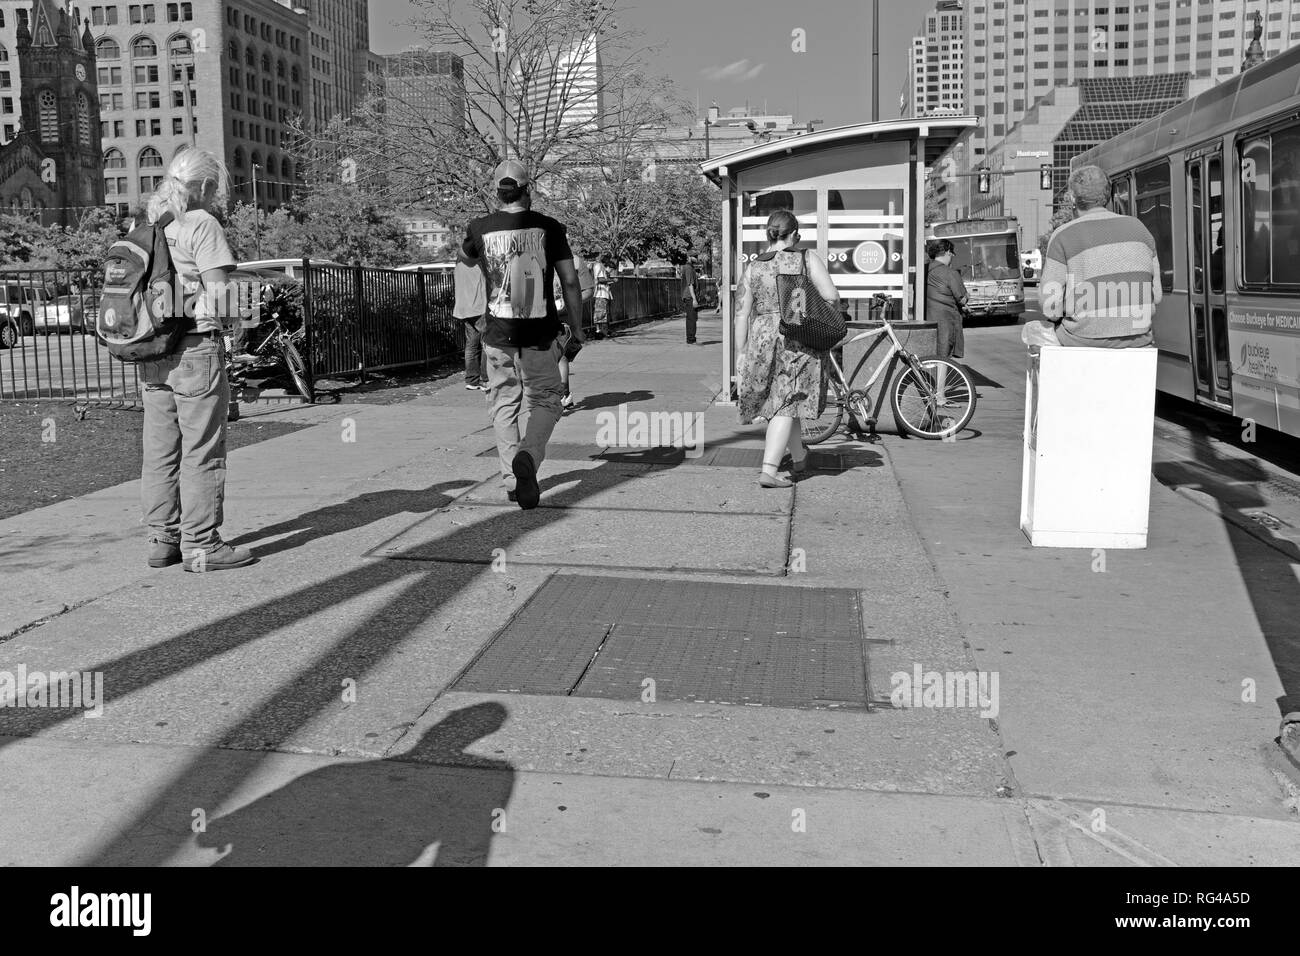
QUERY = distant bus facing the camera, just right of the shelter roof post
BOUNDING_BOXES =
[930,216,1024,319]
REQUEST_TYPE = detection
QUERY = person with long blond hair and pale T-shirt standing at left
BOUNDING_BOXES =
[139,147,256,571]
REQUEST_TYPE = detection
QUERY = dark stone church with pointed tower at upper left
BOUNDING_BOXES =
[0,0,104,225]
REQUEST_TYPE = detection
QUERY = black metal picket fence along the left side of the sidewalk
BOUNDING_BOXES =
[0,260,681,405]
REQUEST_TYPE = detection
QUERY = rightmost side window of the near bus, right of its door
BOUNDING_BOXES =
[1238,126,1300,286]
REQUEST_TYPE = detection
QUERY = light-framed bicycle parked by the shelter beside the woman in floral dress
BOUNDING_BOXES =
[800,321,975,445]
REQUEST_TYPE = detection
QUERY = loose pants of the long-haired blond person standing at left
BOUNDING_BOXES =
[140,336,230,551]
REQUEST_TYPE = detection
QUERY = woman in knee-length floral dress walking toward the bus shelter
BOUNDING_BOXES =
[736,209,840,488]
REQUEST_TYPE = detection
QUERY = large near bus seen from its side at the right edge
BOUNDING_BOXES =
[1074,47,1300,436]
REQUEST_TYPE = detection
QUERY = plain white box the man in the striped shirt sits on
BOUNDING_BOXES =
[1021,345,1156,548]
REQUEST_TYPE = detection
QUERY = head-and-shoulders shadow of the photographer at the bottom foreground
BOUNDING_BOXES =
[196,702,515,866]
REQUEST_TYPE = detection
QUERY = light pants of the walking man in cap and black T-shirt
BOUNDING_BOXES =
[484,343,564,489]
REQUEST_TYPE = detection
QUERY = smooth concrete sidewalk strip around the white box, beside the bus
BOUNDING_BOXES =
[888,329,1296,827]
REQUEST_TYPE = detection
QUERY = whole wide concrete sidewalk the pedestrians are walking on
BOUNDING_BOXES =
[0,315,1300,865]
